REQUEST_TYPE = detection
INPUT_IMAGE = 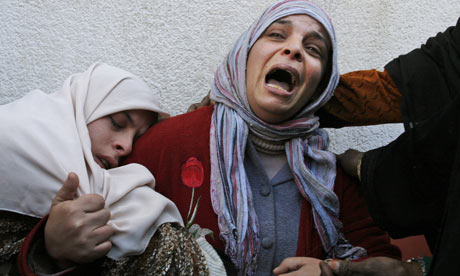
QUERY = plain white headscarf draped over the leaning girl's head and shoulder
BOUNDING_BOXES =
[0,63,182,259]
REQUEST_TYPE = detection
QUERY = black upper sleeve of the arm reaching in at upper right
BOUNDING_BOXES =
[385,18,460,128]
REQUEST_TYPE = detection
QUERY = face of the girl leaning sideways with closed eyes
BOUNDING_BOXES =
[88,110,156,169]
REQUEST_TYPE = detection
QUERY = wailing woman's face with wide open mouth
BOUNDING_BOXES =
[246,15,331,123]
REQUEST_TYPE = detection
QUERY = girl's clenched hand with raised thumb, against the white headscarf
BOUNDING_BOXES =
[45,173,114,269]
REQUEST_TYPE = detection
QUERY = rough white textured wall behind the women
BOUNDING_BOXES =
[0,0,460,152]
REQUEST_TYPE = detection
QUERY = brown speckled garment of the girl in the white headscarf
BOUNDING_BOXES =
[0,212,209,276]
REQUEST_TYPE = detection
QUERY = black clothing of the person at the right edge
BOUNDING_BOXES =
[361,19,460,275]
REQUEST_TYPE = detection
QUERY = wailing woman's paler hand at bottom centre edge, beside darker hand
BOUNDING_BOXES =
[273,257,321,276]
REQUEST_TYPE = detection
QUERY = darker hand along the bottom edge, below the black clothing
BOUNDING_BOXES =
[319,257,423,276]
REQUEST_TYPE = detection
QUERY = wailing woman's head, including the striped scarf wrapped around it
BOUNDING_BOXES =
[212,0,339,125]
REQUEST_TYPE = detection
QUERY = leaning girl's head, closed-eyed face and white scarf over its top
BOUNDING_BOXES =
[76,64,168,169]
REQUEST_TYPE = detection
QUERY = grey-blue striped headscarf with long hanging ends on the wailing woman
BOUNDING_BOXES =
[210,0,366,275]
